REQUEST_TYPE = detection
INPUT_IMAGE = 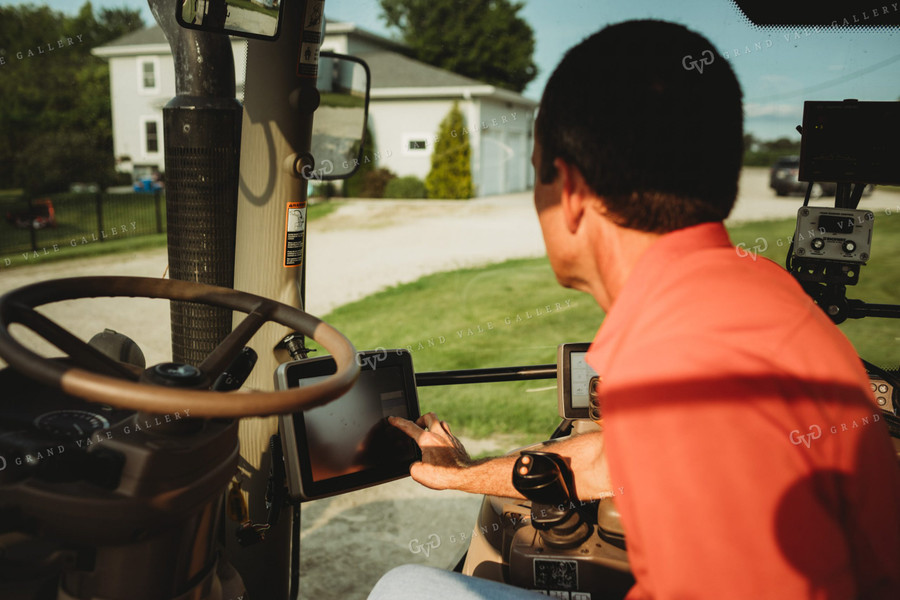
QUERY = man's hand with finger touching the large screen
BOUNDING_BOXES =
[388,413,473,490]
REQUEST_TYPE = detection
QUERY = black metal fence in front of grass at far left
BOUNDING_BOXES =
[0,190,166,268]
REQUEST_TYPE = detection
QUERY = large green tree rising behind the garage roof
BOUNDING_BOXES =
[381,0,537,92]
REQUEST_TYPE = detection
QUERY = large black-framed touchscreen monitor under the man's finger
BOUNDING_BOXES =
[276,349,420,500]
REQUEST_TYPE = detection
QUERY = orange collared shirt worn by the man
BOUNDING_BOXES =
[587,223,900,600]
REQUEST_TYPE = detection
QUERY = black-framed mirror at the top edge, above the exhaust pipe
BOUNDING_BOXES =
[175,0,284,40]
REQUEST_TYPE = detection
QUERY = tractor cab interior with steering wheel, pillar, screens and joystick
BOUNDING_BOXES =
[0,0,900,600]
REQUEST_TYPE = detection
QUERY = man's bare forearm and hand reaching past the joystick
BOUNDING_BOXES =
[390,413,613,500]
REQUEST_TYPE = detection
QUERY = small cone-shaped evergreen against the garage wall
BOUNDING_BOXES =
[425,102,473,200]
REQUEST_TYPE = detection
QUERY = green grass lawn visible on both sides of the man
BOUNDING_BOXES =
[310,215,900,443]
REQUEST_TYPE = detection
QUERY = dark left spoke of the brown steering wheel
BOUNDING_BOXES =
[4,303,143,381]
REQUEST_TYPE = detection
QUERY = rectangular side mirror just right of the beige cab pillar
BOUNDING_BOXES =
[309,52,371,181]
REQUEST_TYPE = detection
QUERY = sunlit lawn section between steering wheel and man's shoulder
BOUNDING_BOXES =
[308,259,603,441]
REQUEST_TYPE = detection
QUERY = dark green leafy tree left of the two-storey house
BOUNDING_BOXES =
[0,2,143,193]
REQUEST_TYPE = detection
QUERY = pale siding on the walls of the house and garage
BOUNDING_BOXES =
[96,25,534,196]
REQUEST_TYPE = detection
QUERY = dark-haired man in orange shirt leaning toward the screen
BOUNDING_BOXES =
[373,21,900,599]
